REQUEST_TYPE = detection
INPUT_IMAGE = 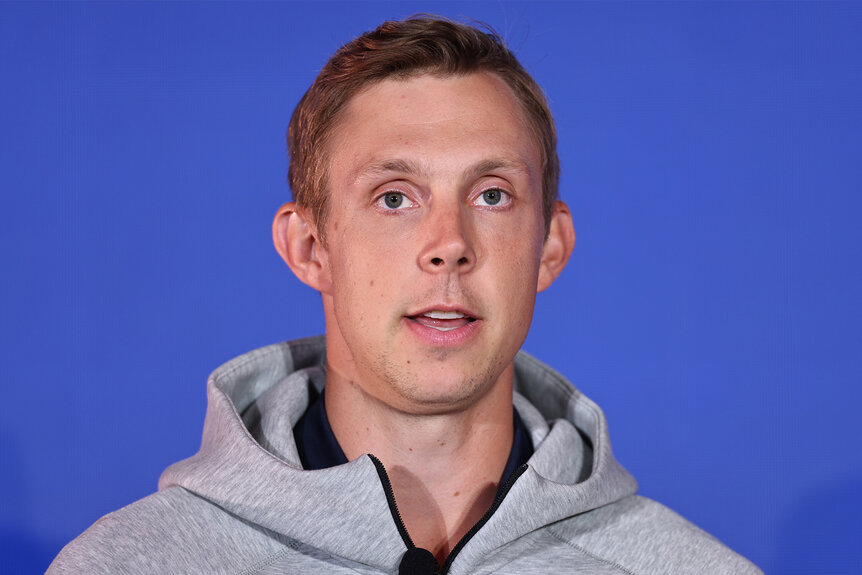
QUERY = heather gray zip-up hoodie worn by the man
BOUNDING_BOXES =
[48,338,760,575]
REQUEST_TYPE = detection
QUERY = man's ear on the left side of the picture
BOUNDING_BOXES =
[272,202,332,292]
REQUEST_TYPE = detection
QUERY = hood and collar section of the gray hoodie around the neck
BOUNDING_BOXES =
[159,337,637,573]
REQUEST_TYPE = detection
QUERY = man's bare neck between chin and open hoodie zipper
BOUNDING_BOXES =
[325,365,513,564]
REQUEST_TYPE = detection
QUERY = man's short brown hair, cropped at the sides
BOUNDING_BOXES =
[287,15,560,241]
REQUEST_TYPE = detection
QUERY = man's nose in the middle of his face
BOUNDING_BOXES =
[419,206,476,274]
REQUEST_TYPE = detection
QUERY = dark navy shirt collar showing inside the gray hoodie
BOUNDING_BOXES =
[293,391,533,486]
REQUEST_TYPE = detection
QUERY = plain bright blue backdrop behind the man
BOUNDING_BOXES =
[0,2,862,573]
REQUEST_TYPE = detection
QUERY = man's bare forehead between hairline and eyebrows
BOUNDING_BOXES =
[330,73,541,184]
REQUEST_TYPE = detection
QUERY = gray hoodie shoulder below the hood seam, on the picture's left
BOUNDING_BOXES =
[48,487,285,575]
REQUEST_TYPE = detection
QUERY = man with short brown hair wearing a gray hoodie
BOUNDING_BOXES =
[50,18,758,574]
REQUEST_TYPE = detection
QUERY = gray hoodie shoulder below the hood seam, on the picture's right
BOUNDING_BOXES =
[549,495,761,575]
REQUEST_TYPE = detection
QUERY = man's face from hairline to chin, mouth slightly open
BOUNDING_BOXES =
[315,73,544,413]
